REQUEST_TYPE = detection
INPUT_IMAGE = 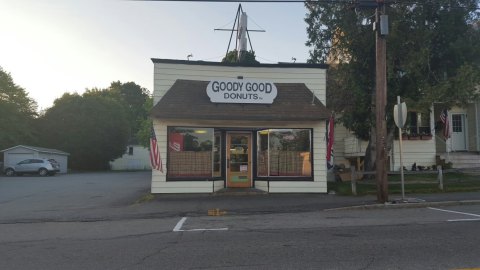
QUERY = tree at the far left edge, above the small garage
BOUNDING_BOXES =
[0,67,37,150]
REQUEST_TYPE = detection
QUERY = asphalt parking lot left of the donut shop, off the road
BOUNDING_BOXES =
[0,171,151,223]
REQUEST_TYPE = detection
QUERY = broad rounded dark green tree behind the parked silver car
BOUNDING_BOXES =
[40,93,130,170]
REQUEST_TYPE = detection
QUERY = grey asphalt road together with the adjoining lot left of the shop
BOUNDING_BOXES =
[0,173,480,269]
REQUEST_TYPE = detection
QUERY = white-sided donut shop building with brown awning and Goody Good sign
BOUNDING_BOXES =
[151,59,330,193]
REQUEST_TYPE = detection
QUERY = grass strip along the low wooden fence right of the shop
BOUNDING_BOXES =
[328,172,480,195]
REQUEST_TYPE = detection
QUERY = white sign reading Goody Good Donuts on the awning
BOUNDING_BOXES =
[207,80,277,104]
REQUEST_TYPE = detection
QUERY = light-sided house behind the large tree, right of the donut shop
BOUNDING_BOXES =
[334,101,480,171]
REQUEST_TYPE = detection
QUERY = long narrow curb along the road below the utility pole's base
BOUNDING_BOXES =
[323,200,480,211]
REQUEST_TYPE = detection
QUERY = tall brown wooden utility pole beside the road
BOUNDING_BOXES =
[374,0,388,203]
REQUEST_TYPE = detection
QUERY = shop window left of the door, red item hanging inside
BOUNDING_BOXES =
[167,127,214,177]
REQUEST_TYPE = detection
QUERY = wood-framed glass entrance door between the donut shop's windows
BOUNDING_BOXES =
[226,133,252,188]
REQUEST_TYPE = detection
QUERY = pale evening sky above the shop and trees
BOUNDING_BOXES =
[0,0,309,111]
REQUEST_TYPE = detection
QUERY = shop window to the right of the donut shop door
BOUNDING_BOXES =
[257,129,312,177]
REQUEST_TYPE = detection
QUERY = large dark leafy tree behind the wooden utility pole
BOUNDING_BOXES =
[305,0,480,170]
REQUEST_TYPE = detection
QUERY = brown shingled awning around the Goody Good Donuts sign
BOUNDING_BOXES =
[152,80,330,121]
